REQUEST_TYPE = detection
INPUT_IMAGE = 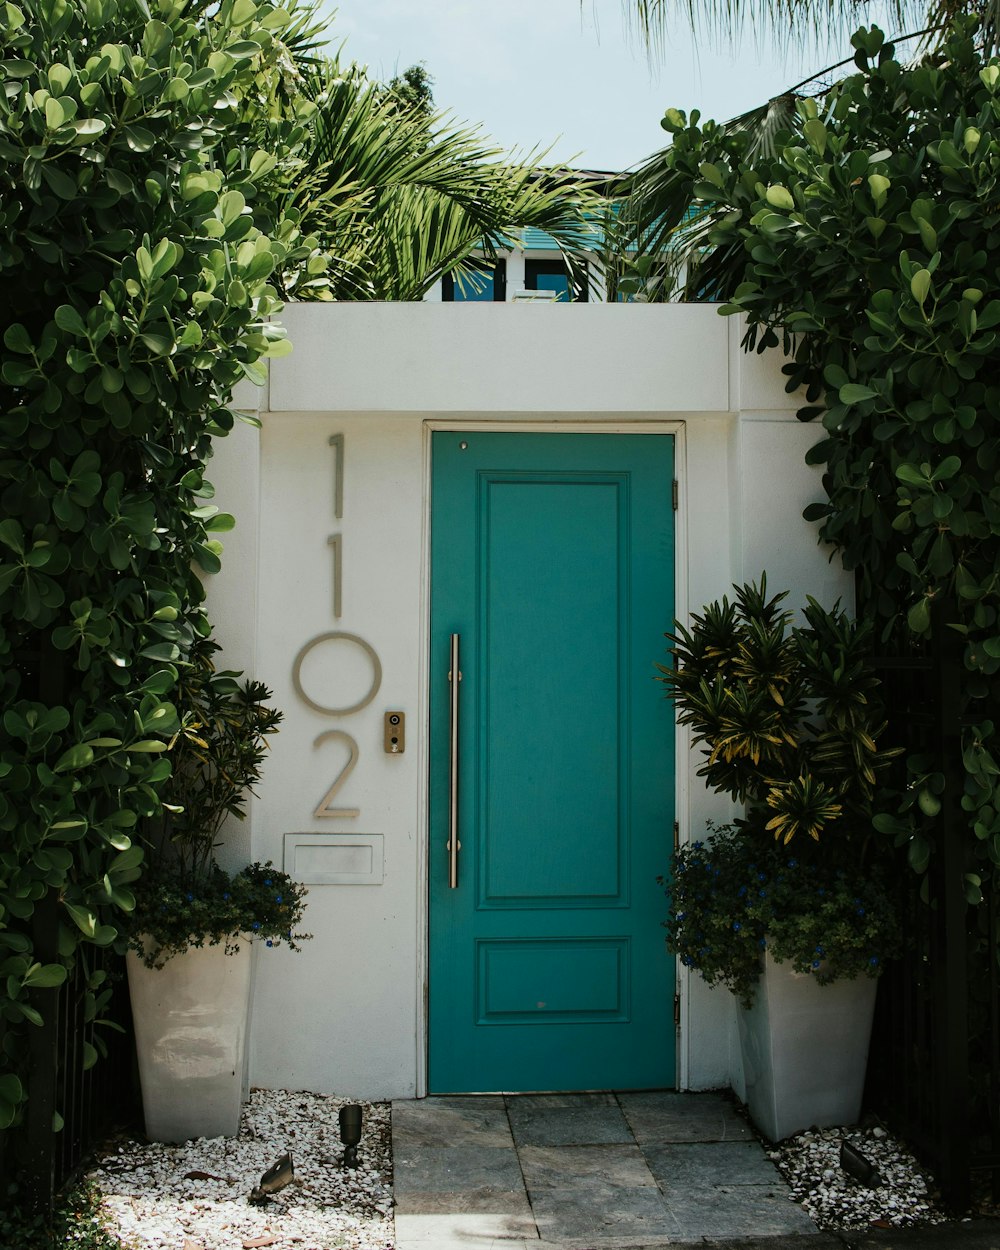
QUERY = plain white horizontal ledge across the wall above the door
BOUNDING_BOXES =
[270,303,730,415]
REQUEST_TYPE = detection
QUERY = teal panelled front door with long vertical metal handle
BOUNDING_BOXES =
[429,431,675,1094]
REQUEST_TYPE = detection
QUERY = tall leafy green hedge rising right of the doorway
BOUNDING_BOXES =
[663,14,1000,900]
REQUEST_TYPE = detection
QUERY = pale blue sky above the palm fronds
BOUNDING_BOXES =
[312,0,900,170]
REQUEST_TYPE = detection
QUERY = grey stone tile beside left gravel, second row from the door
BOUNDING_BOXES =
[393,1145,524,1211]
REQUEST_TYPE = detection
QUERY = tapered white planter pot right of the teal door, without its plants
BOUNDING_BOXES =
[739,953,878,1141]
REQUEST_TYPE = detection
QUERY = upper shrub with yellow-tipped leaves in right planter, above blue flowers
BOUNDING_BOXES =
[658,575,900,845]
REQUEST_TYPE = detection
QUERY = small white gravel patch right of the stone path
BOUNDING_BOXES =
[769,1126,946,1230]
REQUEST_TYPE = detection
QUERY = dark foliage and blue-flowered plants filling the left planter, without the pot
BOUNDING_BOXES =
[129,639,309,968]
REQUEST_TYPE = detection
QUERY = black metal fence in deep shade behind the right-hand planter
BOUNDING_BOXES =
[865,628,1000,1211]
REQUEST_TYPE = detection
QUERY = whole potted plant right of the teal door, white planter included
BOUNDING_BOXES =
[659,576,900,1140]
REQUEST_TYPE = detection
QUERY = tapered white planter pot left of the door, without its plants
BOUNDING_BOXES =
[128,939,253,1141]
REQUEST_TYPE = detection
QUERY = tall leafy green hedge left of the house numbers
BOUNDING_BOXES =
[0,0,324,1128]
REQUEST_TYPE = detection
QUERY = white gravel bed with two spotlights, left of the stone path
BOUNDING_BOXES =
[89,1090,395,1250]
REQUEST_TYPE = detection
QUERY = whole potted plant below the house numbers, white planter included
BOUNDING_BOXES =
[128,639,308,1141]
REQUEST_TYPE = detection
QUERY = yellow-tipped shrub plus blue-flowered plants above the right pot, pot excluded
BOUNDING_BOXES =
[660,576,900,1006]
